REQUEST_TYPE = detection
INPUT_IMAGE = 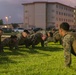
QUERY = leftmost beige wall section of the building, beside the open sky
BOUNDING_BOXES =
[24,4,35,28]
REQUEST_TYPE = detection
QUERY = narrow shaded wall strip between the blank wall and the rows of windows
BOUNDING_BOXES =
[47,3,56,28]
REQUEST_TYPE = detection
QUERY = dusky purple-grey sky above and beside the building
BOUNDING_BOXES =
[0,0,76,23]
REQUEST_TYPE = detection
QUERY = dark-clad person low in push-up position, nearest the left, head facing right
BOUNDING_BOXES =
[2,35,18,50]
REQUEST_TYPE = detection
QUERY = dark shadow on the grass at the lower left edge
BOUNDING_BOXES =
[0,51,22,64]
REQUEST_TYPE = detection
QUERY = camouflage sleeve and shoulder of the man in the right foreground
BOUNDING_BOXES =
[63,33,74,66]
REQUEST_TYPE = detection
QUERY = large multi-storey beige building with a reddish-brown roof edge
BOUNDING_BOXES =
[22,2,75,29]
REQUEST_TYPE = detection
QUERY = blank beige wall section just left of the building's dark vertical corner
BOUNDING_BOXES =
[35,3,46,29]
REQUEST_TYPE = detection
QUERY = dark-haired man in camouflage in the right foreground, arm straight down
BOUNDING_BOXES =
[59,22,74,67]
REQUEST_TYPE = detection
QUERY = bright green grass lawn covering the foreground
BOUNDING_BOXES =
[0,43,76,75]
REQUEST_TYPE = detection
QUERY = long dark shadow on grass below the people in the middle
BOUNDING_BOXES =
[17,46,63,56]
